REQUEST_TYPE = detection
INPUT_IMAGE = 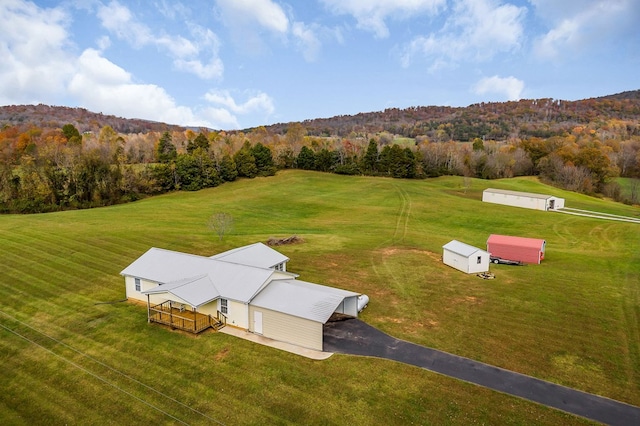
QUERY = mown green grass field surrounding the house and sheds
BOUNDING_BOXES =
[0,171,640,425]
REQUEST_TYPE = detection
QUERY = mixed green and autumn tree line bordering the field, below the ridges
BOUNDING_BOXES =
[0,122,640,213]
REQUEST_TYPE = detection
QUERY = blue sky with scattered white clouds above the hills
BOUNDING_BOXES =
[0,0,640,130]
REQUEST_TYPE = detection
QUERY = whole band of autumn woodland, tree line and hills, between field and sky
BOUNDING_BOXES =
[0,91,640,213]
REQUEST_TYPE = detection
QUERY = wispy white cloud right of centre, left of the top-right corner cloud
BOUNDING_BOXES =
[402,0,526,70]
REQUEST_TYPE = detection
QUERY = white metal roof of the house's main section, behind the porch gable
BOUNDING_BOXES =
[120,247,282,306]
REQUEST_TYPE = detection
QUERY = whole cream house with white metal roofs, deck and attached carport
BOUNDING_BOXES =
[121,243,362,350]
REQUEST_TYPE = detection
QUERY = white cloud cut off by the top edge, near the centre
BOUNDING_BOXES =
[322,0,446,38]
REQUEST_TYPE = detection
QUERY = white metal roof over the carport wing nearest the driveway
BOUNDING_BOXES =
[251,280,360,324]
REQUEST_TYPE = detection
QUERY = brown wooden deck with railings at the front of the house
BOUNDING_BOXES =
[149,300,226,334]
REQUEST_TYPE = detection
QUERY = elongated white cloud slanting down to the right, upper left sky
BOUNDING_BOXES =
[97,1,224,79]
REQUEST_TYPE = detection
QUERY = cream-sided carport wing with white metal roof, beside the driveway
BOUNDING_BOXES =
[249,280,360,351]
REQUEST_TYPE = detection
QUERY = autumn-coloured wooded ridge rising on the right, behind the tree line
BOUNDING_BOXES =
[268,90,640,142]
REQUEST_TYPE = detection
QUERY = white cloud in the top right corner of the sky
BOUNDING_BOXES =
[530,0,640,59]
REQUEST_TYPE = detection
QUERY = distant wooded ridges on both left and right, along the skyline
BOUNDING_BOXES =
[0,90,640,141]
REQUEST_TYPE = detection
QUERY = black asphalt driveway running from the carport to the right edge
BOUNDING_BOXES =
[323,318,640,426]
